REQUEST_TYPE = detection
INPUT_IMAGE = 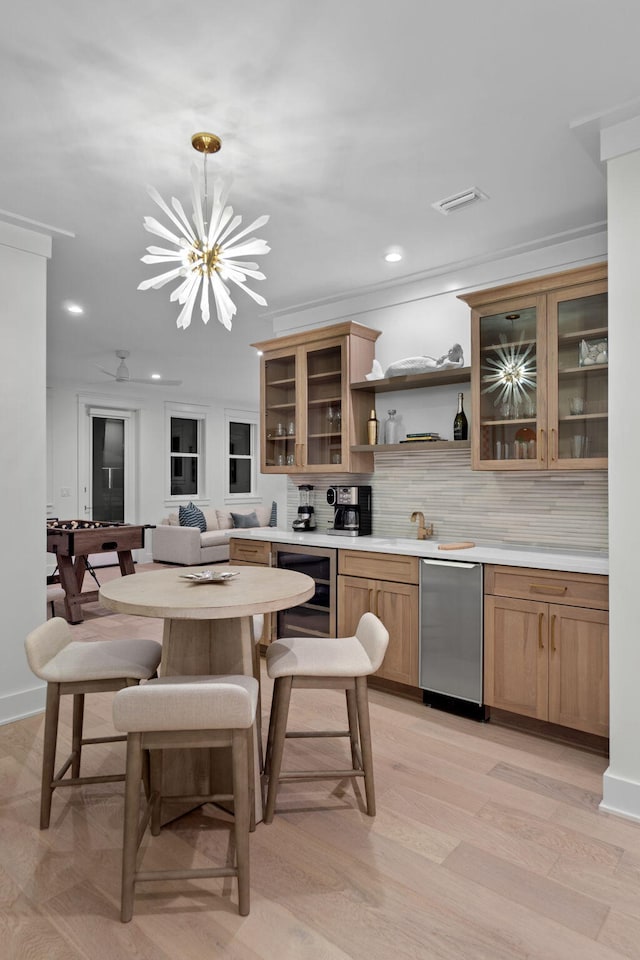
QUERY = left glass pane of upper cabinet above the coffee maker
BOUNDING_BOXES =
[263,353,300,472]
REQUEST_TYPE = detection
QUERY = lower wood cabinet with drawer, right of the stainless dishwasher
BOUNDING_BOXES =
[484,565,609,737]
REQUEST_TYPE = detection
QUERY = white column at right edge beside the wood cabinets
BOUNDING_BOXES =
[601,120,640,820]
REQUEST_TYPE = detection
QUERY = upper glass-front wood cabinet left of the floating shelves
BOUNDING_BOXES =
[252,323,380,474]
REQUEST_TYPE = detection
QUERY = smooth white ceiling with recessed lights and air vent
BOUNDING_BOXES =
[0,0,640,397]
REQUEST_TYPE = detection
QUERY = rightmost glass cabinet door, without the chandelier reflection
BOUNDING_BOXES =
[550,284,609,467]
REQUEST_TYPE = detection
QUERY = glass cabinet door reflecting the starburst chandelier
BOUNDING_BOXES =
[479,299,541,470]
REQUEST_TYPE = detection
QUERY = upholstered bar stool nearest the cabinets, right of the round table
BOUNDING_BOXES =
[264,613,389,823]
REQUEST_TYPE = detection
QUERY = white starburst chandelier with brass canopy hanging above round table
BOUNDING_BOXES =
[138,133,271,330]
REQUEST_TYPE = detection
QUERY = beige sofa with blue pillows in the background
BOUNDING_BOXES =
[152,505,271,566]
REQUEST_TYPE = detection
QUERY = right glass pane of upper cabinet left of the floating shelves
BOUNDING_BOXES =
[307,344,343,466]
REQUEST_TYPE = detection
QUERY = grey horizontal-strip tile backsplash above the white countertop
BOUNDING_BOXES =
[287,449,608,553]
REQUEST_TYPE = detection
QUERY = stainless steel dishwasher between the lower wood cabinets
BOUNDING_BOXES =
[420,560,484,719]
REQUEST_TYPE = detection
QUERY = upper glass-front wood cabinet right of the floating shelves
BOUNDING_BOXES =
[460,264,608,471]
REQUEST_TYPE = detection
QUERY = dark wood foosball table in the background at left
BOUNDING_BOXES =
[47,519,153,623]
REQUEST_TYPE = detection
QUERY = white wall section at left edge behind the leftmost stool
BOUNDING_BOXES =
[0,223,51,723]
